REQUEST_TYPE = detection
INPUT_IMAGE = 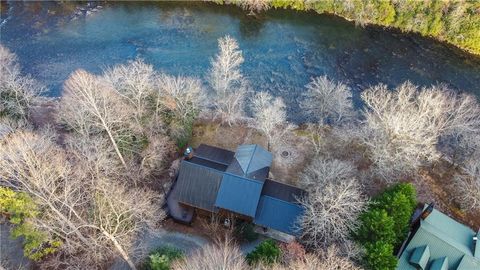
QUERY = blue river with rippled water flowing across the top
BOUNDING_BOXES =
[0,2,480,121]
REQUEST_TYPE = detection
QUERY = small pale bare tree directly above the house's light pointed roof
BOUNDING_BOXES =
[251,92,293,150]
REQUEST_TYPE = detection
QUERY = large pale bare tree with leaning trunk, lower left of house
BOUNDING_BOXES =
[0,131,164,269]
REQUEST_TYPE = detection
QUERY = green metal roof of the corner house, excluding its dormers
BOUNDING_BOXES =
[397,209,480,270]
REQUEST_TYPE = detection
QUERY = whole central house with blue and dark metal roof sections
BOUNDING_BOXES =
[167,144,306,238]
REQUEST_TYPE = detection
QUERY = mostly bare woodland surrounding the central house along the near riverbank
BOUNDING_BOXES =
[0,24,480,269]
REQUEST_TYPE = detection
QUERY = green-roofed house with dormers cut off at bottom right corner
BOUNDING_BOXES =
[397,205,480,270]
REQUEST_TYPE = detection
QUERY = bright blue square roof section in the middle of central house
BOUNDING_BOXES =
[215,173,263,217]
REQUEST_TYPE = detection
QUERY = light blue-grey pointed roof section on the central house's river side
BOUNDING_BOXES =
[227,144,273,181]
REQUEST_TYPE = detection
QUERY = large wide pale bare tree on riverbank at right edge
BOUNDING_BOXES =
[362,82,480,181]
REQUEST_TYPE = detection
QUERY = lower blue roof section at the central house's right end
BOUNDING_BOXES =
[253,195,304,235]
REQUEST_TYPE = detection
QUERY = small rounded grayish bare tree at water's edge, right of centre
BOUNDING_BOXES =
[301,76,354,124]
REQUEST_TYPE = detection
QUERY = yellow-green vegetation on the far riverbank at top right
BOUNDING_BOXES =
[209,0,480,55]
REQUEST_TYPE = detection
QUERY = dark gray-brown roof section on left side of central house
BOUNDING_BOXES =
[173,160,223,212]
